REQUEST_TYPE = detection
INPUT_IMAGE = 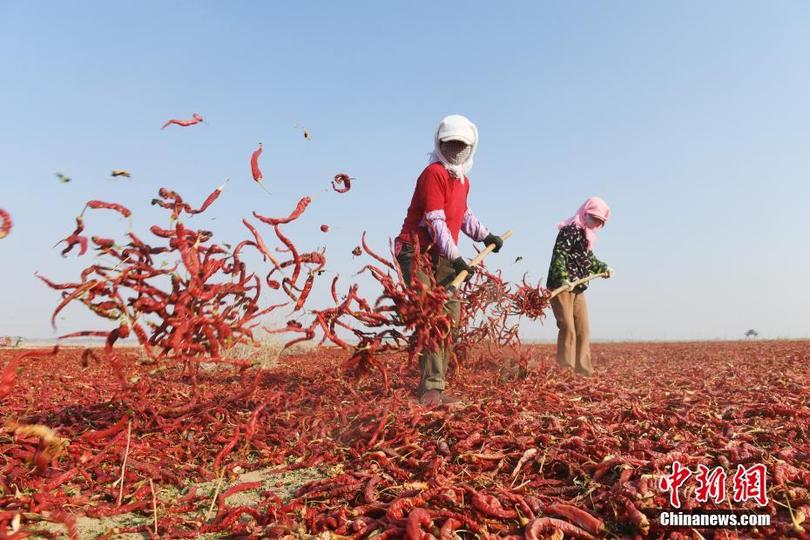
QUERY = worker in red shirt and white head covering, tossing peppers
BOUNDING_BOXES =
[394,114,503,405]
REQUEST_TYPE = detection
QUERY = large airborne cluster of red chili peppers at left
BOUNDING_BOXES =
[38,186,326,392]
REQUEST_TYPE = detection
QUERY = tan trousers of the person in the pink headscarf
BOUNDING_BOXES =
[551,291,593,375]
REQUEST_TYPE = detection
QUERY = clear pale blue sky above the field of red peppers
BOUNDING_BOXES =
[0,0,810,339]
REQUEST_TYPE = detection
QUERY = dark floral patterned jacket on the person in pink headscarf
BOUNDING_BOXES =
[546,224,607,293]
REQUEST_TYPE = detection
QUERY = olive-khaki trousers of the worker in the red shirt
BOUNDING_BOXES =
[397,245,461,396]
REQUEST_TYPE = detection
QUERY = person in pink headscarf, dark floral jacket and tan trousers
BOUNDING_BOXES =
[546,197,614,376]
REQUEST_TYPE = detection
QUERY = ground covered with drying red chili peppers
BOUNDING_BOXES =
[0,341,810,538]
